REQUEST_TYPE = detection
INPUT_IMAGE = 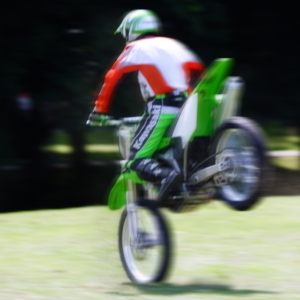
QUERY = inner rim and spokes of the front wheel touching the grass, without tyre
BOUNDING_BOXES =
[122,207,165,283]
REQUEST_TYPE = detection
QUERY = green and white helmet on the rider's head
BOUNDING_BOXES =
[115,9,161,43]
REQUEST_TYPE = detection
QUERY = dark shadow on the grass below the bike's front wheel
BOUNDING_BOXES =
[107,282,276,296]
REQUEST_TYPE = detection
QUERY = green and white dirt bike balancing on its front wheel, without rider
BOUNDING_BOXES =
[88,58,266,283]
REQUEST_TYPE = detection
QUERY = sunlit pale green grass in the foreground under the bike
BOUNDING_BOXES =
[0,196,300,300]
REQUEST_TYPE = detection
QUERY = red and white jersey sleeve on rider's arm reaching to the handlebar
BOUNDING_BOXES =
[95,46,139,113]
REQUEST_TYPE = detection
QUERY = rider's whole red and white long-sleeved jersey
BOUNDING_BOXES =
[95,37,204,113]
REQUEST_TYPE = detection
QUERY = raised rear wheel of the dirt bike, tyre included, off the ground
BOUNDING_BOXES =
[210,117,267,211]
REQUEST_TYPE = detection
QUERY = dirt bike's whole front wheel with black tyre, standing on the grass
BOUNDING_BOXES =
[119,199,171,284]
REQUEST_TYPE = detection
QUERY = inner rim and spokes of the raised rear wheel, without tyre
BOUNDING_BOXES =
[216,129,261,202]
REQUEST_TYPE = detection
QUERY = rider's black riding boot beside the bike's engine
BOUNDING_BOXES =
[130,159,181,199]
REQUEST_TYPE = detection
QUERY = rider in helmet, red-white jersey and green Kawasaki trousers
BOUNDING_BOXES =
[88,9,205,197]
